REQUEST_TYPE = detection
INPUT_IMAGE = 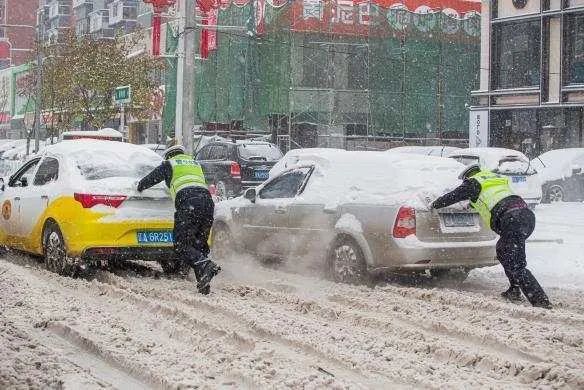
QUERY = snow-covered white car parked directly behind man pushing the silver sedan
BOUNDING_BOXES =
[448,148,541,208]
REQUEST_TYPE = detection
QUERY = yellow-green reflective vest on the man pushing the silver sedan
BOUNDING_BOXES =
[470,170,514,227]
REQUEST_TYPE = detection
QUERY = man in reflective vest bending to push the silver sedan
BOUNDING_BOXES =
[431,165,551,309]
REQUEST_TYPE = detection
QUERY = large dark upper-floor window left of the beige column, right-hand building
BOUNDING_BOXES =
[492,20,541,89]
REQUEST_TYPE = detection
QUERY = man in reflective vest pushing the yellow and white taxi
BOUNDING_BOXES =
[137,145,221,295]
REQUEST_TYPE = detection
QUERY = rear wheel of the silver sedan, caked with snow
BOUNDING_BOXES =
[329,238,367,284]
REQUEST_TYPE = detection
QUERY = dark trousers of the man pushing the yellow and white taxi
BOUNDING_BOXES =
[174,190,215,275]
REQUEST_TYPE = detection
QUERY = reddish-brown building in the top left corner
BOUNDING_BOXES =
[0,0,38,69]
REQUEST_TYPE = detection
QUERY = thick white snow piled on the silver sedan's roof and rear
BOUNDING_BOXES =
[270,149,464,207]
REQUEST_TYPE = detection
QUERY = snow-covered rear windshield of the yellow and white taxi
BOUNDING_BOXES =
[73,151,160,180]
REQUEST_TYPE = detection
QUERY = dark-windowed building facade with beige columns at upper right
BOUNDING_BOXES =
[469,0,584,157]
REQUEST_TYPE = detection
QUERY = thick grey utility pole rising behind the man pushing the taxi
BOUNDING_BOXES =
[179,0,196,154]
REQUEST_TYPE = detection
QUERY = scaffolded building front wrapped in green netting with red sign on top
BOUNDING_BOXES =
[163,0,480,150]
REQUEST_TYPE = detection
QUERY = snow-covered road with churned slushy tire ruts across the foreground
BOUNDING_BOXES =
[0,204,584,389]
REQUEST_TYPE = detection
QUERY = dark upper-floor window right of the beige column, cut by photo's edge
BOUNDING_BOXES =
[564,14,584,84]
